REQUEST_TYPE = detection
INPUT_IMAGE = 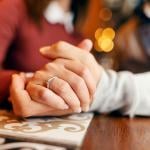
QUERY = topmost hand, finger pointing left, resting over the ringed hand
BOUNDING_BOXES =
[40,40,103,83]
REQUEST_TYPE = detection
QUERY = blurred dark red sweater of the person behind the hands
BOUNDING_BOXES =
[0,0,81,100]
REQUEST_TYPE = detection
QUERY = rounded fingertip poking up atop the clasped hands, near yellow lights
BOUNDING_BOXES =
[78,39,93,52]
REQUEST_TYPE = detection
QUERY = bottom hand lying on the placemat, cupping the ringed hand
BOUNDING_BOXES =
[10,73,73,117]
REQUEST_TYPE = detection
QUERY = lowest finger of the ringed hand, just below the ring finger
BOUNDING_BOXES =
[26,70,71,110]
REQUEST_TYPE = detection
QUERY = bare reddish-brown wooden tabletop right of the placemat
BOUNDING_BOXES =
[81,115,150,150]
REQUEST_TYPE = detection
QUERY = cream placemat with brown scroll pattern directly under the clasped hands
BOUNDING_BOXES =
[0,111,93,148]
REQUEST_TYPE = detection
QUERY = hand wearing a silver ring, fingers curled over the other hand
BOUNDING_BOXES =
[26,59,96,112]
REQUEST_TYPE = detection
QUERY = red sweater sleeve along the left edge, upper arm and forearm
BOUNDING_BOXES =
[0,0,22,101]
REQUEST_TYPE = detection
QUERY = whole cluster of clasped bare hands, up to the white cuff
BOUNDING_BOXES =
[10,40,102,117]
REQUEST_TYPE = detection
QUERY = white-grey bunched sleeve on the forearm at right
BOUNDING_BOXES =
[91,70,150,117]
